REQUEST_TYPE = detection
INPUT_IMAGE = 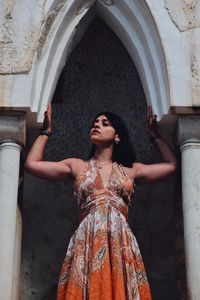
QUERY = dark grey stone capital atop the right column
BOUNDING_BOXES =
[177,116,200,145]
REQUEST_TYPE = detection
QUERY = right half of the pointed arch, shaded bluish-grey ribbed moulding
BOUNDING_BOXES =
[97,0,170,119]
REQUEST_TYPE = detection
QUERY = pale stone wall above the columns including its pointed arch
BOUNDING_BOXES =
[0,0,200,116]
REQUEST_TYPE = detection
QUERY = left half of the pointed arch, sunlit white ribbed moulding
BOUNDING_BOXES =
[30,0,95,122]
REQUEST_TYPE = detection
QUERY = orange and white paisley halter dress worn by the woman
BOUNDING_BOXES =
[57,158,151,300]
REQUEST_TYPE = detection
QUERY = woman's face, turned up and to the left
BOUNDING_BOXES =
[90,115,118,145]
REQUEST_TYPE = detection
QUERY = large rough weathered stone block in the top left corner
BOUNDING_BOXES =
[0,0,44,74]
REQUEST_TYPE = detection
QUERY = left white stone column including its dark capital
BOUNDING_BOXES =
[0,112,25,300]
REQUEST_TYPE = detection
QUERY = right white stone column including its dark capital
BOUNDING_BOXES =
[178,116,200,300]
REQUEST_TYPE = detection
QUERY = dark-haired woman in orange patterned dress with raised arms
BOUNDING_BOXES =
[25,106,176,300]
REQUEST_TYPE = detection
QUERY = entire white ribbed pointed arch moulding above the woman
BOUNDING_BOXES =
[31,0,170,121]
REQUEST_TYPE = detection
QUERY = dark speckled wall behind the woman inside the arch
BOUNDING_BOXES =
[20,18,181,300]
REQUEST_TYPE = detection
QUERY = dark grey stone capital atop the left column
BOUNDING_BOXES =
[0,111,26,146]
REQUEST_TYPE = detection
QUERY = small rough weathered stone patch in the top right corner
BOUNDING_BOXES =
[165,0,200,31]
